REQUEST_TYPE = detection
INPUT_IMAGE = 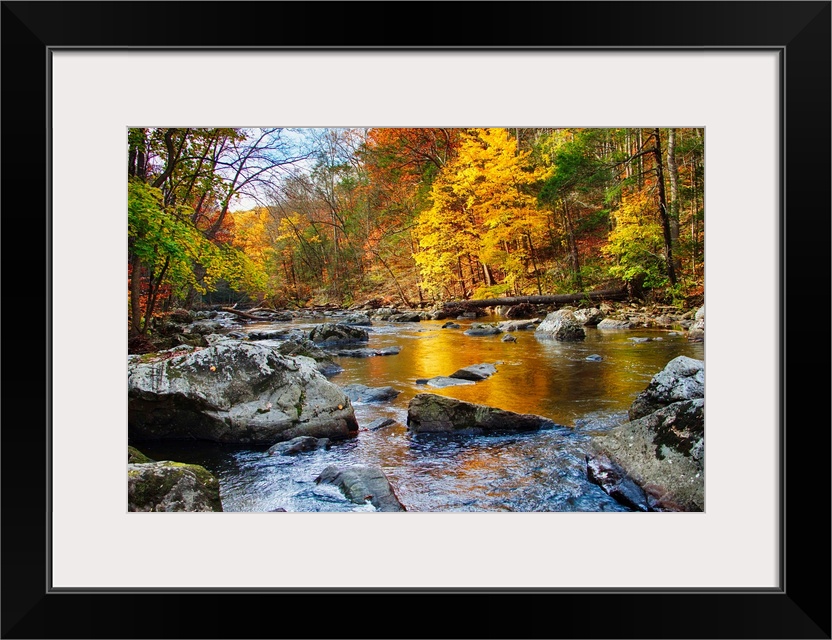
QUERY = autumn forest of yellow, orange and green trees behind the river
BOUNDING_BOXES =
[127,127,704,336]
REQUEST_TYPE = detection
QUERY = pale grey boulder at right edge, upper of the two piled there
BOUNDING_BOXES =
[629,356,705,420]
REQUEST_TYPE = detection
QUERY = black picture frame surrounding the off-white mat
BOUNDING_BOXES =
[0,1,832,638]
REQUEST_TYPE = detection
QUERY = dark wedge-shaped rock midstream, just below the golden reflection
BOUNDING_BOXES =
[407,393,558,433]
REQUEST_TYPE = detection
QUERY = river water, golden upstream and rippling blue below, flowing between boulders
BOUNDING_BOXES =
[138,317,704,512]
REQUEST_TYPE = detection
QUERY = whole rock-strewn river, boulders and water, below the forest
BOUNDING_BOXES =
[128,304,704,511]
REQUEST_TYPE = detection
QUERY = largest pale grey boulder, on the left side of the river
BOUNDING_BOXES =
[128,342,358,445]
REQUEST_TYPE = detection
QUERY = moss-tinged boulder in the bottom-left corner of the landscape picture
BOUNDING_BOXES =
[127,460,222,511]
